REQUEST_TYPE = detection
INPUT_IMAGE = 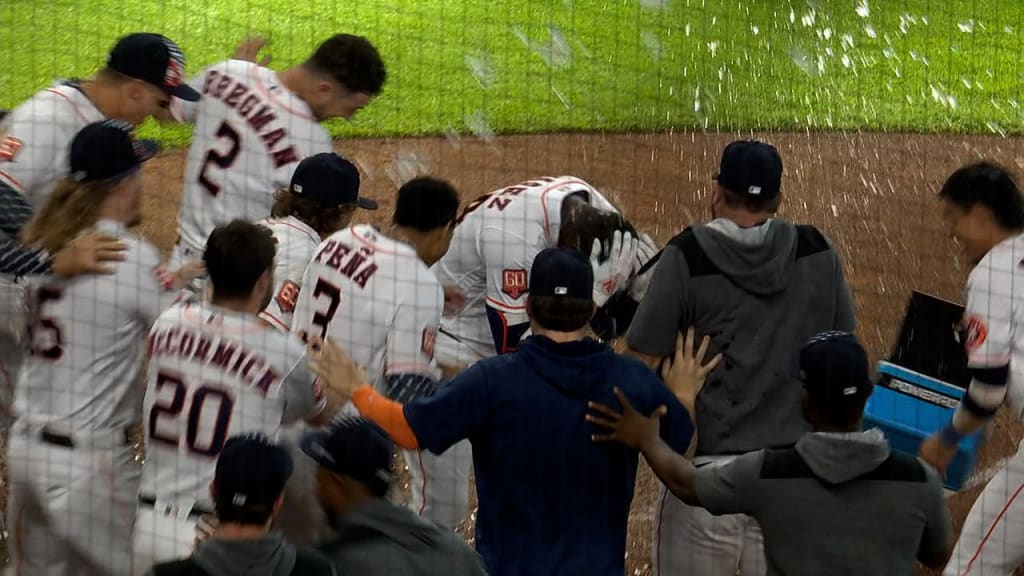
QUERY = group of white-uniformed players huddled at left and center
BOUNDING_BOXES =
[0,34,655,574]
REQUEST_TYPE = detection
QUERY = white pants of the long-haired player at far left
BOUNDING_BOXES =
[7,422,141,576]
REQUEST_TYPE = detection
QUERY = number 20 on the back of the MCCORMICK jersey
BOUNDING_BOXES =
[148,372,234,456]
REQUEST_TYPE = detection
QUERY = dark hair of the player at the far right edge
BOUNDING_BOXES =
[939,161,1024,231]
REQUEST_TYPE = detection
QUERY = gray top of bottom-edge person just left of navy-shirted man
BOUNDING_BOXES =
[321,498,486,576]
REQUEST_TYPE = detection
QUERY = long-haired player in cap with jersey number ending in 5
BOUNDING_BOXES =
[7,120,199,575]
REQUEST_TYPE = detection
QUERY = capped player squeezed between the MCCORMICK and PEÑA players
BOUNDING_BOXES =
[259,152,377,332]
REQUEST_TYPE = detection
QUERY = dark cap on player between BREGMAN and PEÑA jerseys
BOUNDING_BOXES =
[289,152,377,210]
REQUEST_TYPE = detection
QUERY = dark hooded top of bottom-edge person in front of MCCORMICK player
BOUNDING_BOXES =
[146,532,335,576]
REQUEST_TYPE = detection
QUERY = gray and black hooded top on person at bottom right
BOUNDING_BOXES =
[696,428,951,576]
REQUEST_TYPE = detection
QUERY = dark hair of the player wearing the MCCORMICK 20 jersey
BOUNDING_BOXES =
[203,220,276,298]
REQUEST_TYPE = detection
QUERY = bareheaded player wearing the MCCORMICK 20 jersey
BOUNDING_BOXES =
[132,220,356,574]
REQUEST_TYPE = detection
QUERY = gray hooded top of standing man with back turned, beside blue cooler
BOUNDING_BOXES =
[627,219,856,455]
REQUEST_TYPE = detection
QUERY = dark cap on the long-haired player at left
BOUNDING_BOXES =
[70,120,158,182]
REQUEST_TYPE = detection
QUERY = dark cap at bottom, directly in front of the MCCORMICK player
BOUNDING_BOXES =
[213,434,293,508]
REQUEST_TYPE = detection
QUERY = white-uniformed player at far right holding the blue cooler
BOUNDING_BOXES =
[920,162,1024,576]
